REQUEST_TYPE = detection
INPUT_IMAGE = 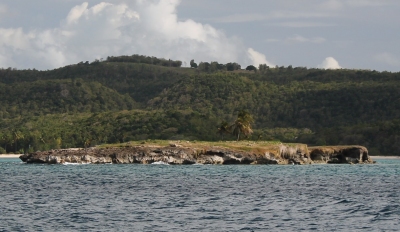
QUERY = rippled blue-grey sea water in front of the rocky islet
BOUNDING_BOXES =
[0,159,400,231]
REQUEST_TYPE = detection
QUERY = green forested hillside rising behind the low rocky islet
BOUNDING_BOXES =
[0,56,400,155]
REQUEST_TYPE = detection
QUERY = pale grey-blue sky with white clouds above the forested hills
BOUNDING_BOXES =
[0,0,400,72]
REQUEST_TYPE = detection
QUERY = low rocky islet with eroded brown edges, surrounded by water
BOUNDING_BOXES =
[19,144,374,165]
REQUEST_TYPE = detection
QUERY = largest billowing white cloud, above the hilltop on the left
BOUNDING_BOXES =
[0,0,268,69]
